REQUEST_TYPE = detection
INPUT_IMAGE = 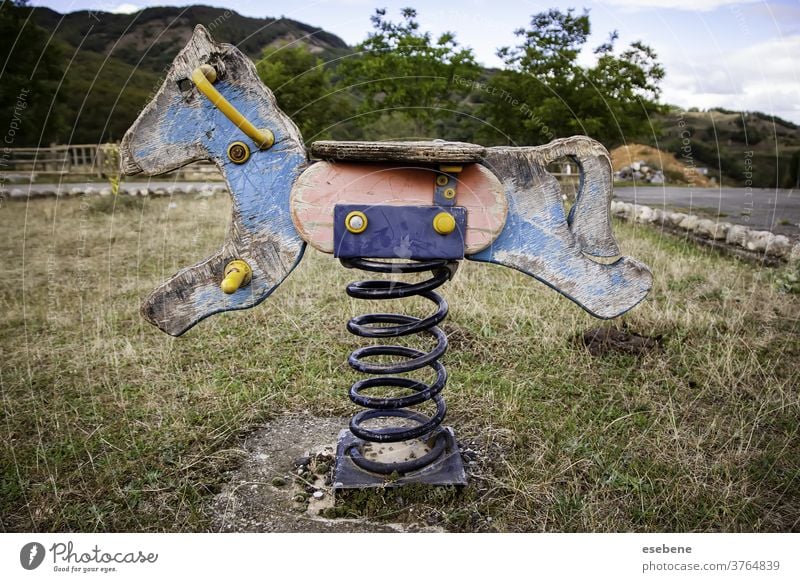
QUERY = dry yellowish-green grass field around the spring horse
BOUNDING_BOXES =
[0,196,800,531]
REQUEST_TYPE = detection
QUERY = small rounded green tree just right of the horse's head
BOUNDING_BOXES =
[256,44,352,140]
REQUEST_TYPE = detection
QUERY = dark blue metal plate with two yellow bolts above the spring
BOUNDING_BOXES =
[333,204,467,260]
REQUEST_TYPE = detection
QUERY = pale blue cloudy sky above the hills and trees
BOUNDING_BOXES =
[30,0,800,123]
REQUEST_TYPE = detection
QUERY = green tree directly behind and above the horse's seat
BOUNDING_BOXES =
[337,8,479,137]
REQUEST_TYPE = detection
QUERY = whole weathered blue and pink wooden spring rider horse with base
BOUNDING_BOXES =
[121,26,652,488]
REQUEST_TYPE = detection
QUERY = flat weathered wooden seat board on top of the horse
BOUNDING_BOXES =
[311,140,486,164]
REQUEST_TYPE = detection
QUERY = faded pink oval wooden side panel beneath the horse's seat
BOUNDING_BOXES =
[291,162,507,254]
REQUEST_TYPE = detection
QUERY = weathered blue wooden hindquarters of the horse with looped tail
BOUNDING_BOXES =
[467,137,652,319]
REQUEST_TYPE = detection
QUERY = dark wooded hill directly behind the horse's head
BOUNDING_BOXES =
[18,6,348,145]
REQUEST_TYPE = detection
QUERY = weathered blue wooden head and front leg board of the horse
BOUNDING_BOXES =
[121,26,307,335]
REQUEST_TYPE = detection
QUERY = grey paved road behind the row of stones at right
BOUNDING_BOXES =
[614,186,800,236]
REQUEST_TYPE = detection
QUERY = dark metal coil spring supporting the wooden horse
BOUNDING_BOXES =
[340,259,457,474]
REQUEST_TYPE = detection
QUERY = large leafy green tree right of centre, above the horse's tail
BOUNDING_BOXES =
[481,9,664,146]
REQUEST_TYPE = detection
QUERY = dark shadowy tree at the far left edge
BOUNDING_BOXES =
[0,0,63,147]
